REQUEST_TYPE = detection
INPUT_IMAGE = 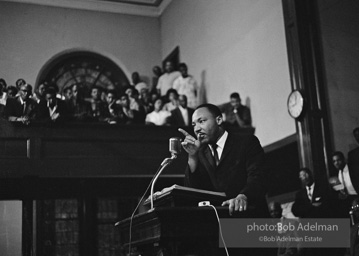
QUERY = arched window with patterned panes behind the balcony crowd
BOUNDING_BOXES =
[38,51,129,96]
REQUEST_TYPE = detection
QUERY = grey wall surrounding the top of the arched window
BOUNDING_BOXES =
[0,1,161,85]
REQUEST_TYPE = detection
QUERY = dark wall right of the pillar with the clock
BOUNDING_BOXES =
[318,0,359,155]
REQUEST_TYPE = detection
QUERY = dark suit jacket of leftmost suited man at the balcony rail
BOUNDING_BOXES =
[4,96,37,119]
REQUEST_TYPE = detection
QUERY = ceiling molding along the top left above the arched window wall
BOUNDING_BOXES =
[0,0,172,17]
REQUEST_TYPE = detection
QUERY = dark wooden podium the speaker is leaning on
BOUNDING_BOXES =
[117,186,252,256]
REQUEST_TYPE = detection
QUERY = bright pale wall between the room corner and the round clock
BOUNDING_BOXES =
[161,0,296,146]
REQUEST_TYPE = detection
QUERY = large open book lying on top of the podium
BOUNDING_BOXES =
[143,184,226,207]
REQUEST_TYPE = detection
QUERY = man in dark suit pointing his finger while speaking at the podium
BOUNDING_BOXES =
[179,104,269,217]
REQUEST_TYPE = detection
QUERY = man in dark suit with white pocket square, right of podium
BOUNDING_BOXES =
[292,168,336,218]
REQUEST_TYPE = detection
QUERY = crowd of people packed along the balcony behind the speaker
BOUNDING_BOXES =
[0,61,251,130]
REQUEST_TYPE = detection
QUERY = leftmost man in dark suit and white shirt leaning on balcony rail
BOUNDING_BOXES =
[4,84,37,124]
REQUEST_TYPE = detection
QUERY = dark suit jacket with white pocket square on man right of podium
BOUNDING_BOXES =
[292,182,338,218]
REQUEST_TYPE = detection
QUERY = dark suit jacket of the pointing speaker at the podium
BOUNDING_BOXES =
[185,133,269,217]
